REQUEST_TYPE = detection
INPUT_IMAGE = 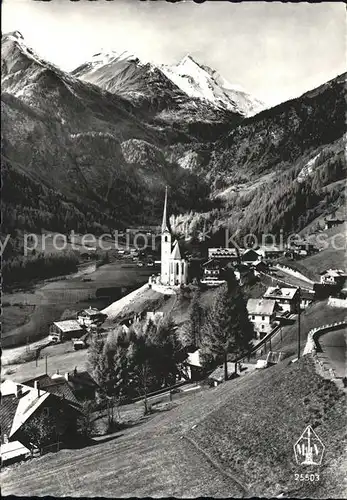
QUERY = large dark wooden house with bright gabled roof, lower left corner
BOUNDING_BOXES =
[0,380,82,456]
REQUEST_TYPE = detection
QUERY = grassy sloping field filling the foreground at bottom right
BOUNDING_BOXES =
[2,357,345,498]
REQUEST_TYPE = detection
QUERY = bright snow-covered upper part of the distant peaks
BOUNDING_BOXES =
[71,44,265,117]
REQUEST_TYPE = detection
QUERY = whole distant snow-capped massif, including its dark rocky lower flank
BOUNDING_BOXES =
[72,52,265,121]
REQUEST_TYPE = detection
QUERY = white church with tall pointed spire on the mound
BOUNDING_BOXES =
[160,188,188,286]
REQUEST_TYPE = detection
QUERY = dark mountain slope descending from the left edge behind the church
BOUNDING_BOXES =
[2,33,222,236]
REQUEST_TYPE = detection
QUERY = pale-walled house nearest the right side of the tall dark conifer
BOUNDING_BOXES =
[247,299,279,339]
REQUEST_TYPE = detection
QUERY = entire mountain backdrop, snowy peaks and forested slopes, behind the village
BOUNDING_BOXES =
[1,32,346,247]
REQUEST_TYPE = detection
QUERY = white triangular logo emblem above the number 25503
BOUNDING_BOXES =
[294,425,325,465]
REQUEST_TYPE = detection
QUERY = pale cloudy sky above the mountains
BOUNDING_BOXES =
[2,0,346,104]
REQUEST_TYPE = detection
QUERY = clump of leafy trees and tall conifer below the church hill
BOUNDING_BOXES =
[89,271,253,412]
